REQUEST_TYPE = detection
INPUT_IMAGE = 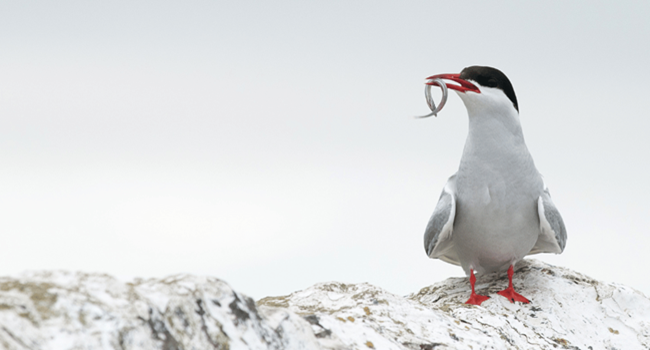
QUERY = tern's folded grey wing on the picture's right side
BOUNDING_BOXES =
[528,186,566,254]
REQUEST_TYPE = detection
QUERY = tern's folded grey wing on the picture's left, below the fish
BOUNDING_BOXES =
[424,175,460,265]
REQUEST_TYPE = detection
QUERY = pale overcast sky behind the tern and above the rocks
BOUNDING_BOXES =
[0,0,650,298]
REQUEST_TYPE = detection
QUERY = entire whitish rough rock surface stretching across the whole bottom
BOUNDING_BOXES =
[0,260,650,350]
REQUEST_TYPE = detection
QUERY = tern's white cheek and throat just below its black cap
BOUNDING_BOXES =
[457,80,519,117]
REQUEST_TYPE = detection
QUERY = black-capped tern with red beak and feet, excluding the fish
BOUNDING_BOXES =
[424,66,567,305]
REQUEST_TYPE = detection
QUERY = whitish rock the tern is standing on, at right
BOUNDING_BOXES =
[258,260,650,349]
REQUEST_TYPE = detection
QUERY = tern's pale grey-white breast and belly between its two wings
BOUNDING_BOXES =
[453,91,543,273]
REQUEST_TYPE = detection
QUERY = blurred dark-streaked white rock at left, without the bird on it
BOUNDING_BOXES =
[0,272,319,350]
